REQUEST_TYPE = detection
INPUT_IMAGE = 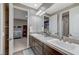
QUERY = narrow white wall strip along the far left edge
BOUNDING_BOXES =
[0,3,4,54]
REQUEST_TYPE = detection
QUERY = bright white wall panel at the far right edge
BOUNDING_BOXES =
[69,6,79,37]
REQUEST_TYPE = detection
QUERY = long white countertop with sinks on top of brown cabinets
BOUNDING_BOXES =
[30,34,79,55]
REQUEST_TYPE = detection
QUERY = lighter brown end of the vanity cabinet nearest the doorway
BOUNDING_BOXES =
[29,36,43,55]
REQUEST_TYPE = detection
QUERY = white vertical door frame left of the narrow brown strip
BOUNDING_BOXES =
[0,3,5,55]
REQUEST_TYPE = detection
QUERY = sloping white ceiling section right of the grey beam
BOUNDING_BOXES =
[47,3,74,14]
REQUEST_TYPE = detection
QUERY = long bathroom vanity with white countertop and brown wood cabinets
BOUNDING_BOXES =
[29,33,79,55]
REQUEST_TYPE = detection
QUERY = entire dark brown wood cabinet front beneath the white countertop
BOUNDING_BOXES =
[29,36,62,55]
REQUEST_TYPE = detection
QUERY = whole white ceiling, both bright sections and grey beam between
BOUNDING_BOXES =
[21,3,74,15]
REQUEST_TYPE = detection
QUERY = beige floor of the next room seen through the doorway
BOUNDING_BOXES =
[14,38,27,52]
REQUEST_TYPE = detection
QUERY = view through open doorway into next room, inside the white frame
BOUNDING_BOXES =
[13,8,28,53]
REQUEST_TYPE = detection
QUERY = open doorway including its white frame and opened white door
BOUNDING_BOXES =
[9,3,33,55]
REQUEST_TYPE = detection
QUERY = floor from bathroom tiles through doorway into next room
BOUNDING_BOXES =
[14,38,34,55]
